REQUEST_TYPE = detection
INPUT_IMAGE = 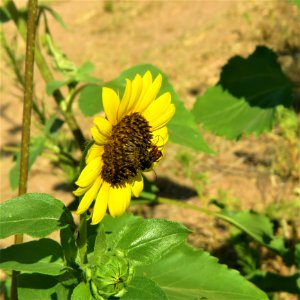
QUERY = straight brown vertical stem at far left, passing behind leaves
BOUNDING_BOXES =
[11,0,38,300]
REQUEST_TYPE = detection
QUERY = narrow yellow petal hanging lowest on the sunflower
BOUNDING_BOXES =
[91,181,110,225]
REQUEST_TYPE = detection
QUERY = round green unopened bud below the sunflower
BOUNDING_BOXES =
[86,251,134,300]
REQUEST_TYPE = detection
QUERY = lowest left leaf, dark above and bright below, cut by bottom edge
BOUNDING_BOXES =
[18,273,59,300]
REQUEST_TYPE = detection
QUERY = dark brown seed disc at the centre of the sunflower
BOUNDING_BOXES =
[101,112,161,187]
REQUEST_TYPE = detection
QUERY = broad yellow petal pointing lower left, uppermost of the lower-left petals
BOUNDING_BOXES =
[75,157,103,187]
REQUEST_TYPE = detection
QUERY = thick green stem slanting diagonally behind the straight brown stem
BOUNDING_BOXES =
[4,0,85,151]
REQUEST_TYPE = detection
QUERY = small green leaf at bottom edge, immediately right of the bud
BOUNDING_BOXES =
[122,276,168,300]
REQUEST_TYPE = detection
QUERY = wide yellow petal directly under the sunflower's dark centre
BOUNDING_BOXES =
[108,185,131,218]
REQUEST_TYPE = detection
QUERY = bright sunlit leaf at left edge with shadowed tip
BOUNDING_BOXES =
[0,193,73,238]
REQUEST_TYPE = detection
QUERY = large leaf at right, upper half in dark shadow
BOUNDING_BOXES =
[193,47,292,139]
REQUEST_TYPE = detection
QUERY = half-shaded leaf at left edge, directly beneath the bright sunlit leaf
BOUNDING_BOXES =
[0,239,64,275]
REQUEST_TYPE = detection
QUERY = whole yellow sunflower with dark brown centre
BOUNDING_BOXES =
[74,71,175,224]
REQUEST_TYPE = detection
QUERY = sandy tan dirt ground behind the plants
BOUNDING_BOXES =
[0,0,300,299]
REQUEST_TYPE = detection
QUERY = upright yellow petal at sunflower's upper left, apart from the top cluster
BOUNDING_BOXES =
[102,87,120,125]
